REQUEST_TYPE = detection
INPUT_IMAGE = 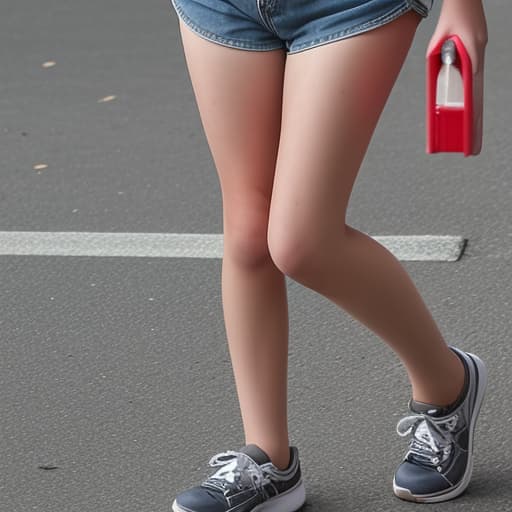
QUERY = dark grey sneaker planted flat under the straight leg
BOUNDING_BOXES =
[172,444,306,512]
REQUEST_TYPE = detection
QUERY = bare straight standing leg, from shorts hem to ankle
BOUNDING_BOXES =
[180,20,289,468]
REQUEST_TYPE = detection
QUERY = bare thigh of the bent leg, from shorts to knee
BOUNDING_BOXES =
[269,11,420,245]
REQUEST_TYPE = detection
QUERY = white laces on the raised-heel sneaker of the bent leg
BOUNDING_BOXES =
[396,414,458,472]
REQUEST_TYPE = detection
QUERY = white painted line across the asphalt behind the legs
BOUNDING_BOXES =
[0,231,466,261]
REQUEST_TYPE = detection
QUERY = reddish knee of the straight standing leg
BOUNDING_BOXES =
[224,213,272,268]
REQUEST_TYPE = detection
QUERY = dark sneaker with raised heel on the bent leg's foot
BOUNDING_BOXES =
[393,347,487,503]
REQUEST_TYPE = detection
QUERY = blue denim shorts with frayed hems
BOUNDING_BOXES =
[171,0,434,54]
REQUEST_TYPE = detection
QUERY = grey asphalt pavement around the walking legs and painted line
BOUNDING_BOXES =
[0,0,512,512]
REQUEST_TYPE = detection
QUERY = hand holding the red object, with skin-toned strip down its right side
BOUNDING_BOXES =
[426,0,488,155]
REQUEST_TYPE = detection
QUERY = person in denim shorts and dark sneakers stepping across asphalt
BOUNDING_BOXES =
[167,0,487,512]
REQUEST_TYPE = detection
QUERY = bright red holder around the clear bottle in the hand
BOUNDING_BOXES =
[426,35,477,156]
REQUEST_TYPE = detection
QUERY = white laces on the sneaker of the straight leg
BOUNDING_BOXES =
[201,450,270,495]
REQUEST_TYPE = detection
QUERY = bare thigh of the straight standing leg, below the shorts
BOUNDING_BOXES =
[180,20,285,234]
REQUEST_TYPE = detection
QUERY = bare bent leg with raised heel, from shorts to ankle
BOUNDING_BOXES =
[269,11,464,405]
